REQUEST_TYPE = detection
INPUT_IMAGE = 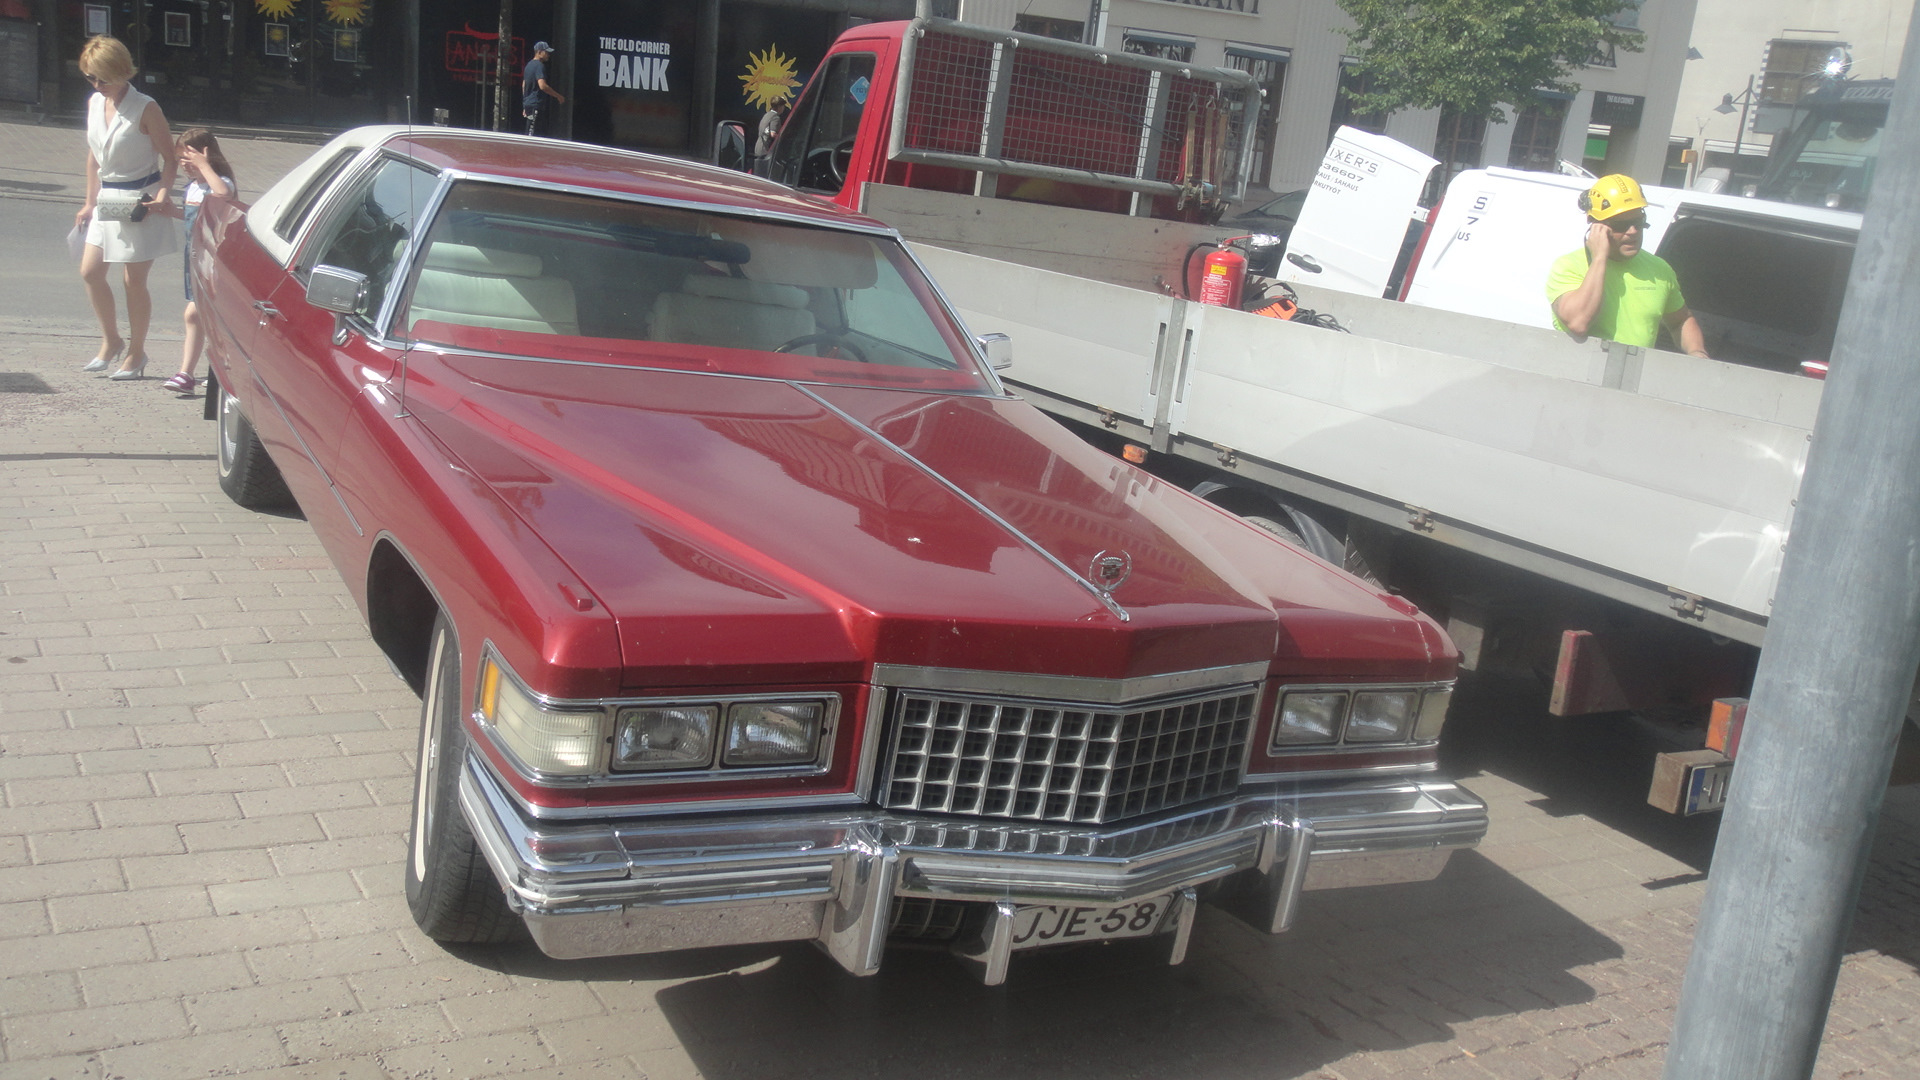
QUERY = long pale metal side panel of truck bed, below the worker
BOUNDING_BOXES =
[1171,309,1809,615]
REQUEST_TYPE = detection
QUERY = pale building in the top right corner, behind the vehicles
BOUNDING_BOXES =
[1668,0,1912,183]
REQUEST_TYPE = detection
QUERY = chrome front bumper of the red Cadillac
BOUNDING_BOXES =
[461,757,1486,984]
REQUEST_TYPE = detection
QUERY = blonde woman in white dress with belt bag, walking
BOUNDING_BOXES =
[73,35,180,379]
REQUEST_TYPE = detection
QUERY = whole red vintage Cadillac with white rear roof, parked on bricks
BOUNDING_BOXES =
[192,127,1486,982]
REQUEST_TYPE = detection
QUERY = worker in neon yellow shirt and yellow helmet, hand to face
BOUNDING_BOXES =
[1548,175,1707,357]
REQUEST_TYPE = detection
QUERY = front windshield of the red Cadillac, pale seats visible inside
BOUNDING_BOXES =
[397,181,989,392]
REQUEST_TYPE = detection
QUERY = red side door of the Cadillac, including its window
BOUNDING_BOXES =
[255,156,440,532]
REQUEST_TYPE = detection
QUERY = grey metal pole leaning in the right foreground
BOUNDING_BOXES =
[1665,4,1920,1080]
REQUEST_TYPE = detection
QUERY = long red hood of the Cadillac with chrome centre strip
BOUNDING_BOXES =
[409,354,1452,686]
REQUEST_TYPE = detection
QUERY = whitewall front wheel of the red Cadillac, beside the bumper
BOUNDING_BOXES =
[407,613,522,944]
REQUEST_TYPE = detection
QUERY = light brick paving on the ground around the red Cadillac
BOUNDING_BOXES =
[0,125,1920,1080]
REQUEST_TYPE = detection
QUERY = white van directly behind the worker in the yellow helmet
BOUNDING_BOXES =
[1290,155,1860,371]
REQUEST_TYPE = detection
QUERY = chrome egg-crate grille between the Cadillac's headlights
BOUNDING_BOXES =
[881,686,1260,824]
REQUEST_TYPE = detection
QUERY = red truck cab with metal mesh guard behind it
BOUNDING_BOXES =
[730,19,1260,221]
